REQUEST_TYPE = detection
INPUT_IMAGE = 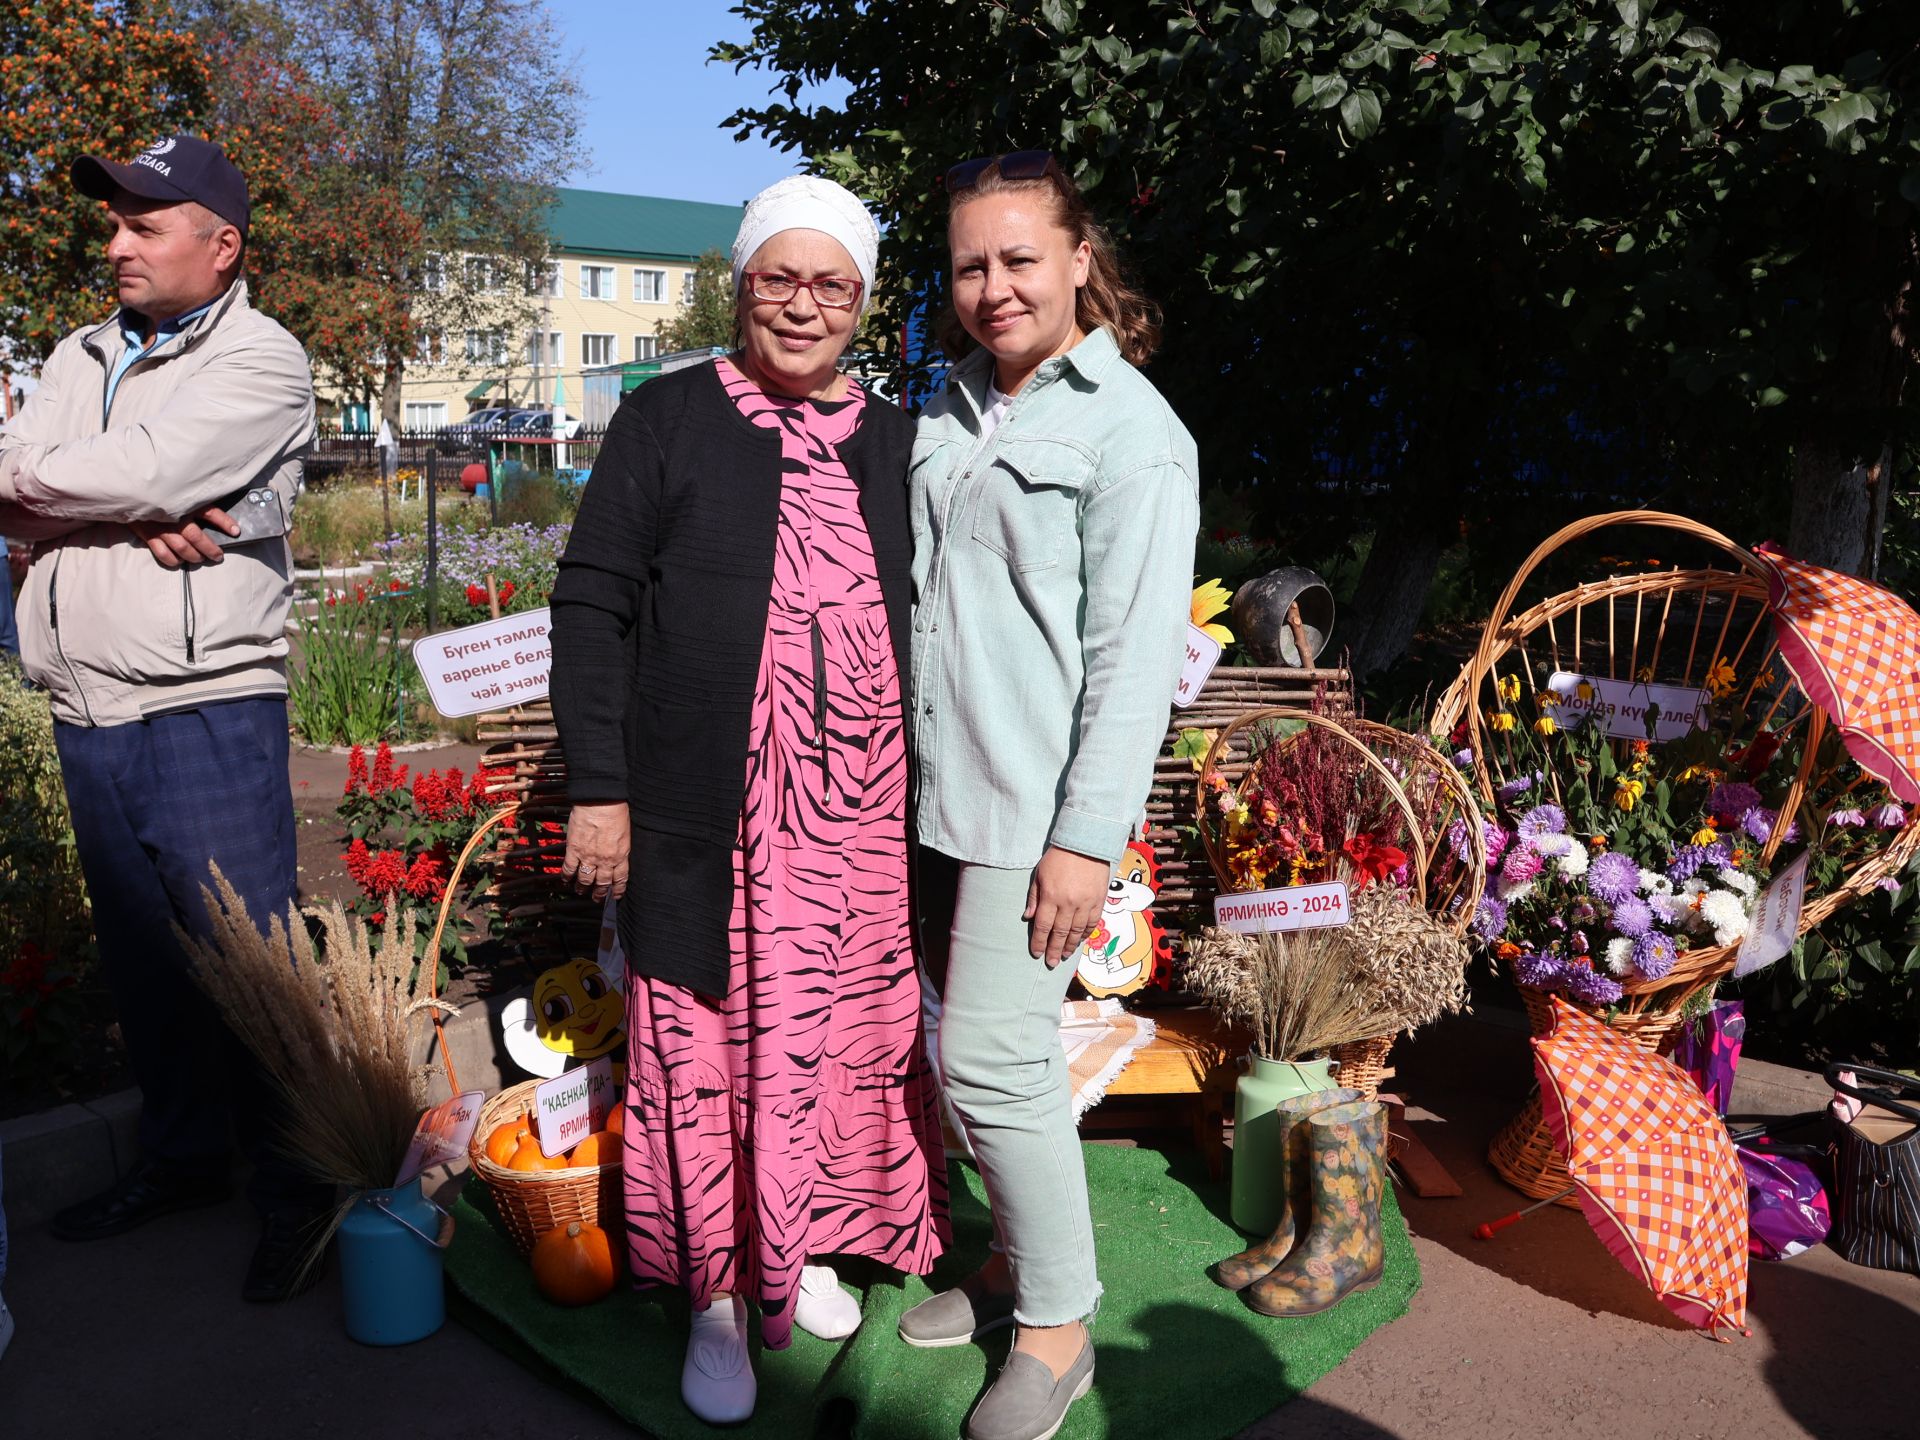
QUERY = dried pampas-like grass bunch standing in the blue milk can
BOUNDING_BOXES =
[180,866,451,1192]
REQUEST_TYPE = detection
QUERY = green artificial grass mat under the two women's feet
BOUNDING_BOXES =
[447,1144,1421,1440]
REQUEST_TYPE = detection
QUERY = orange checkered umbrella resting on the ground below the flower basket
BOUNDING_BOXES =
[1532,996,1747,1334]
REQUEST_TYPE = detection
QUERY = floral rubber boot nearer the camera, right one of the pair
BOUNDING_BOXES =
[1242,1100,1386,1317]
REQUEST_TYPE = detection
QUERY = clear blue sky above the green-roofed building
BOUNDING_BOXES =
[547,0,839,205]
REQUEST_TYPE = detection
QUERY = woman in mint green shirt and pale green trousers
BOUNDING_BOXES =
[900,150,1200,1440]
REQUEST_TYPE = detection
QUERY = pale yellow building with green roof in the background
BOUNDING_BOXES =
[344,188,741,430]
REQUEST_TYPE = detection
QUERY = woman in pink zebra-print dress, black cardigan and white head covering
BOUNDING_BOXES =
[551,177,947,1423]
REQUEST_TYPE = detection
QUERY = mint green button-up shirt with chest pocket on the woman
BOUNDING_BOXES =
[910,330,1200,870]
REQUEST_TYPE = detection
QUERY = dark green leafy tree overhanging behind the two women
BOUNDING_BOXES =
[714,0,1920,670]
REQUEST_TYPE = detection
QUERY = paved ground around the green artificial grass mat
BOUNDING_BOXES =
[0,1018,1920,1440]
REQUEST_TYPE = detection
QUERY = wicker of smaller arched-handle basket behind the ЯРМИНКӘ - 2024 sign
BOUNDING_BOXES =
[1194,707,1486,1098]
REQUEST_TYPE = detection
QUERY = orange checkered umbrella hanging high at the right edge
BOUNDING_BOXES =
[1755,545,1920,804]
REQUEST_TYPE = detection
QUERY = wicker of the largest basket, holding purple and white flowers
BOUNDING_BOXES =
[1430,511,1920,1196]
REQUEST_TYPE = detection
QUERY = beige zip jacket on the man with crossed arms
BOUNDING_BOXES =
[0,280,313,726]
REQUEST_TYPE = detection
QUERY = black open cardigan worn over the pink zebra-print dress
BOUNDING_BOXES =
[549,365,914,995]
